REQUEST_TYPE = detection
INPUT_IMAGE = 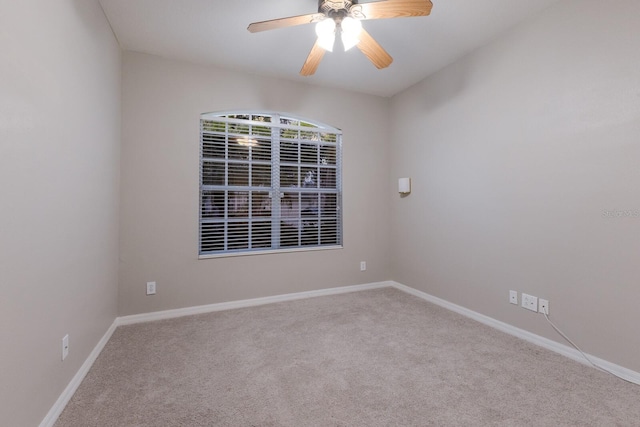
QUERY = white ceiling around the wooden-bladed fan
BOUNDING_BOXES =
[100,0,560,96]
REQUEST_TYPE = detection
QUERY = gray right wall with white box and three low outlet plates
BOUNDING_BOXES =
[390,0,640,371]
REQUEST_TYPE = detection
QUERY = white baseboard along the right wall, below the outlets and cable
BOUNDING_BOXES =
[390,281,640,385]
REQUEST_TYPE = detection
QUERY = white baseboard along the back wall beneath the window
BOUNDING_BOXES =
[116,282,393,326]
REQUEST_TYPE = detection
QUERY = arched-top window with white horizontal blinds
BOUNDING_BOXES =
[199,113,342,257]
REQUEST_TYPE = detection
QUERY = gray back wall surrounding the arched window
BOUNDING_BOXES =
[119,52,393,315]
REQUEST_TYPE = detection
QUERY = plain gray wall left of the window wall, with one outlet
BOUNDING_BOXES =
[0,0,121,426]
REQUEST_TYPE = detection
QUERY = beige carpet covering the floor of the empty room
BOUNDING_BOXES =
[56,288,640,427]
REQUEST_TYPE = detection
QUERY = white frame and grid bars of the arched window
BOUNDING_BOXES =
[198,110,344,259]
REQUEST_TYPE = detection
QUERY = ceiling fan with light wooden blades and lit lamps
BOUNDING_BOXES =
[247,0,433,76]
